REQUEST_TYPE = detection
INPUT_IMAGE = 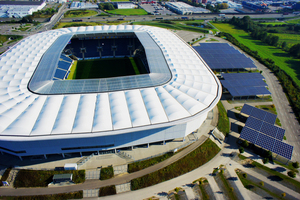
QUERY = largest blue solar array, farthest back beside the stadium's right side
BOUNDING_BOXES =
[193,43,256,70]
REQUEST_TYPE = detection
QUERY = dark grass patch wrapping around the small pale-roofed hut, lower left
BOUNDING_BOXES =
[14,169,85,188]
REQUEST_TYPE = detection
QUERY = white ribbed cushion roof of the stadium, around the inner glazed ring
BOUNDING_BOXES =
[0,25,221,140]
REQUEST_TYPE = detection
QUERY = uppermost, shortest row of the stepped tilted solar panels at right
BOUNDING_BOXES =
[241,104,277,124]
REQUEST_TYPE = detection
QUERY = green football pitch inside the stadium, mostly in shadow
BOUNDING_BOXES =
[68,57,147,80]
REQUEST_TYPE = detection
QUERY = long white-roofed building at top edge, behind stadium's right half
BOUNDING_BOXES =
[165,2,210,15]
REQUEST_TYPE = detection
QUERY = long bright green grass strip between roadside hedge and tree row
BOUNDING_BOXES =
[213,23,300,86]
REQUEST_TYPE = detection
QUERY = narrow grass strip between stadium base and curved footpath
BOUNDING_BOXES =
[128,152,174,173]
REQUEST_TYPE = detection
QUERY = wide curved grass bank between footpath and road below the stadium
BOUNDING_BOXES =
[131,139,220,190]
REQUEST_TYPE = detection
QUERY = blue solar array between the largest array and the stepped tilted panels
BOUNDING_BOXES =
[220,73,271,97]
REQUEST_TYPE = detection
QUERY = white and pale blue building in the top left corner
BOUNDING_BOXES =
[0,1,46,18]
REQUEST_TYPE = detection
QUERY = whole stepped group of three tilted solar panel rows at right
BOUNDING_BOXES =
[240,104,294,160]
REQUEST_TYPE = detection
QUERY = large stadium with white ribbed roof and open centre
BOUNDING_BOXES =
[0,25,222,158]
